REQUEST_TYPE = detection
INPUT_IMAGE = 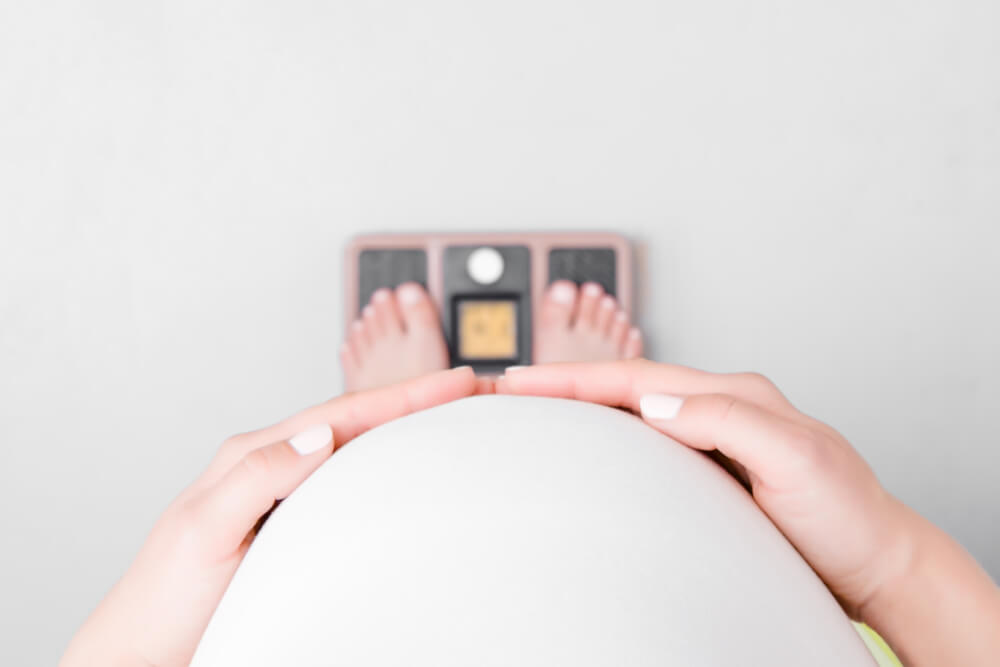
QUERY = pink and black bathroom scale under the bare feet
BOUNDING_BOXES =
[344,232,633,374]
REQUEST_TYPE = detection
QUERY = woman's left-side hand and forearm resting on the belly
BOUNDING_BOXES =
[61,368,489,666]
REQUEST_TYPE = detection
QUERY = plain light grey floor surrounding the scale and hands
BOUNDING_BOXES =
[0,0,1000,665]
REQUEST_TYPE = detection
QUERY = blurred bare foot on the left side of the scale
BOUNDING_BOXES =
[340,283,448,391]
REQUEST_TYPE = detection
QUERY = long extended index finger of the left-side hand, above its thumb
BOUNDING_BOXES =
[199,366,478,484]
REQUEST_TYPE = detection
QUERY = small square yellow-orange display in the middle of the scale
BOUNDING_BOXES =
[458,299,517,360]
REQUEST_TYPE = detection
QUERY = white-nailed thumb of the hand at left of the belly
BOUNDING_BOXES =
[192,424,334,556]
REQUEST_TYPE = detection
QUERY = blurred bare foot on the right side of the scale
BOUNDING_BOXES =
[535,280,642,364]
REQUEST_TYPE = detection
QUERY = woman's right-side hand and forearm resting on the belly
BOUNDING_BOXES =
[496,360,1000,665]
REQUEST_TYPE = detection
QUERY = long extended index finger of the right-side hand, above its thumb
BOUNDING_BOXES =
[496,359,798,417]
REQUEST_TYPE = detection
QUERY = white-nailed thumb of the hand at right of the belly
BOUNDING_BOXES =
[640,394,830,490]
